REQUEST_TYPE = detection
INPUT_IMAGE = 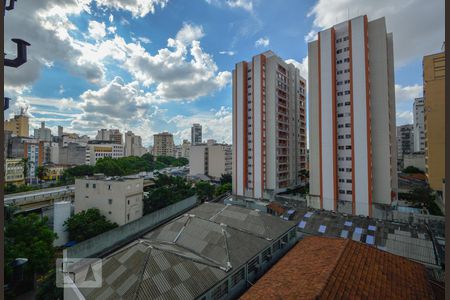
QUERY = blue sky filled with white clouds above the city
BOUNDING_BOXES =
[4,0,445,146]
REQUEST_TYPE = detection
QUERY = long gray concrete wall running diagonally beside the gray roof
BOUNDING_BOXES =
[63,196,197,258]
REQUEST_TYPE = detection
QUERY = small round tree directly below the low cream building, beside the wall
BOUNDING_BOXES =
[64,208,118,242]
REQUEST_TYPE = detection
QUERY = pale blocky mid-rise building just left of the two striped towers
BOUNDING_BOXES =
[189,140,233,180]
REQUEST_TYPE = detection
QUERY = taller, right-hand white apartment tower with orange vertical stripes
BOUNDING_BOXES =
[308,16,397,217]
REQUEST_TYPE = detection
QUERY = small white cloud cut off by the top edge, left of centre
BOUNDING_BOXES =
[96,0,169,18]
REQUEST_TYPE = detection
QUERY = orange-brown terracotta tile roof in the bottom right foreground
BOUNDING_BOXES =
[241,237,433,300]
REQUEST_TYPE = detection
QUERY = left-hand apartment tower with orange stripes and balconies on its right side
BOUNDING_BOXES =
[233,51,306,199]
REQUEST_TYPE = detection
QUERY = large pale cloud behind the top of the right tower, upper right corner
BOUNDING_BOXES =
[308,0,445,66]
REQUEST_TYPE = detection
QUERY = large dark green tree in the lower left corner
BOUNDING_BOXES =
[5,214,57,278]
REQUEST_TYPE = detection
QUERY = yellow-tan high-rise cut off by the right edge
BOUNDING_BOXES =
[423,52,445,191]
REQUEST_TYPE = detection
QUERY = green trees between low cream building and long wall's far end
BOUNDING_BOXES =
[144,174,195,215]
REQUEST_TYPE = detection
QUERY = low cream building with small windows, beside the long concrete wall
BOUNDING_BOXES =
[75,176,144,226]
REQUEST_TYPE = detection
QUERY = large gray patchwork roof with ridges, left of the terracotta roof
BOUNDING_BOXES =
[75,203,295,299]
